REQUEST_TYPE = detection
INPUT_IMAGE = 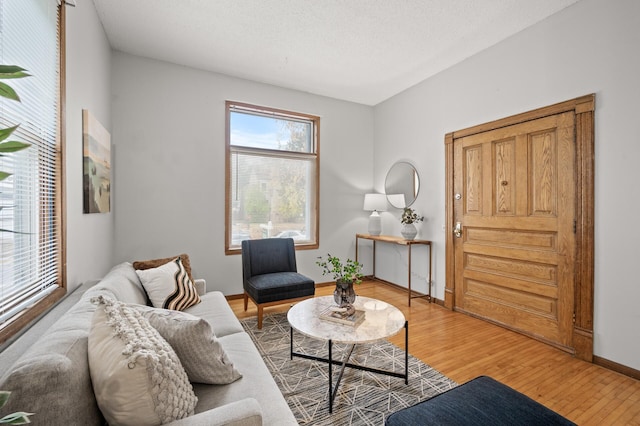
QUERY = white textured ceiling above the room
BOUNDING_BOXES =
[93,0,579,105]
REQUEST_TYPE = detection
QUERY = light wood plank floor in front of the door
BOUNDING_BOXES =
[229,281,640,425]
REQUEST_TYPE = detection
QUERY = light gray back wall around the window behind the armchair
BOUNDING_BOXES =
[112,52,373,295]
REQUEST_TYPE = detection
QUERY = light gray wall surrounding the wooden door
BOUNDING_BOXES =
[374,0,640,369]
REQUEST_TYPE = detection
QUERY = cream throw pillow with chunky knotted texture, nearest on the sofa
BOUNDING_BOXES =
[88,296,198,426]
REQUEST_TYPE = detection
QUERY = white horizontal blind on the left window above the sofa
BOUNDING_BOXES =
[0,0,60,329]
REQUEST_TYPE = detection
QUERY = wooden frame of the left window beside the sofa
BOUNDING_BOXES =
[0,1,67,350]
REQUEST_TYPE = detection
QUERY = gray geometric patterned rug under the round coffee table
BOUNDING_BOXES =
[241,313,457,426]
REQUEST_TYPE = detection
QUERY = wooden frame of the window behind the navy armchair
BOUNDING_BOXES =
[224,101,320,255]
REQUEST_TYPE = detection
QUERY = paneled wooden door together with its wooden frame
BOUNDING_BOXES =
[444,95,595,361]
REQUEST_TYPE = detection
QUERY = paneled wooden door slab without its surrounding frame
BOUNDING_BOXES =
[453,111,576,351]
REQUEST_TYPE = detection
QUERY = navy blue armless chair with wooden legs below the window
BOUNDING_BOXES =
[242,238,315,329]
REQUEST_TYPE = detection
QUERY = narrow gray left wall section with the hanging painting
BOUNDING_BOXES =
[65,1,114,290]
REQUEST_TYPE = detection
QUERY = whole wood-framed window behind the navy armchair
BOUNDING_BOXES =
[225,102,320,253]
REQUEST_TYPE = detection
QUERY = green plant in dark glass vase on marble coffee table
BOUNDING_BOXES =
[316,254,363,312]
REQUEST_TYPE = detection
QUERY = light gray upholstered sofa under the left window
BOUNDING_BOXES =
[0,263,297,426]
